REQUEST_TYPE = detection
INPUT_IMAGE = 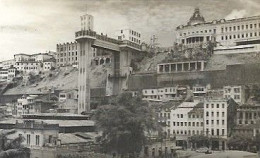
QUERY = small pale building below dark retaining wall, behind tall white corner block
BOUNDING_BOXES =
[223,86,245,104]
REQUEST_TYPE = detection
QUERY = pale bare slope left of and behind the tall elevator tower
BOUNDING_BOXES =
[5,66,107,95]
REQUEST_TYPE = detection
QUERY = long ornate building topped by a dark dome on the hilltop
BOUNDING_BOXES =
[176,8,260,54]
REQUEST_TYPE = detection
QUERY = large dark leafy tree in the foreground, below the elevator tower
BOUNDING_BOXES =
[94,93,158,157]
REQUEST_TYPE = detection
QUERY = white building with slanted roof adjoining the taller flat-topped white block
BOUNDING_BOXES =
[170,101,203,148]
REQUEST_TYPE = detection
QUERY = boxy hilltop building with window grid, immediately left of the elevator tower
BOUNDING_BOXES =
[56,42,78,66]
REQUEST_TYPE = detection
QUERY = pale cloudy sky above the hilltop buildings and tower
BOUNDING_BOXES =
[0,0,260,61]
